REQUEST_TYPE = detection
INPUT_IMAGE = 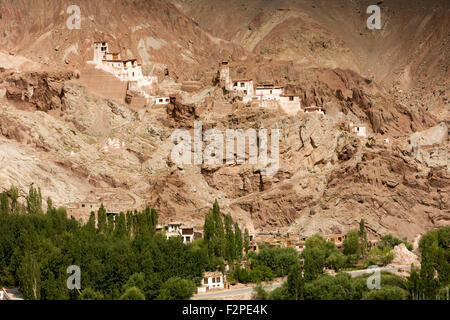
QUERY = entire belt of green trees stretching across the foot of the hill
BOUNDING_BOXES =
[0,187,450,300]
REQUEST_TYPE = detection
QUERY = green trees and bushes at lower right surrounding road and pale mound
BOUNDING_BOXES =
[254,226,450,300]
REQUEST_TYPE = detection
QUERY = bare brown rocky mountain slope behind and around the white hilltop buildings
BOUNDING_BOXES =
[0,0,450,239]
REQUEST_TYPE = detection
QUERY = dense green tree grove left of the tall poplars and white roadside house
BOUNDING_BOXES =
[0,187,208,300]
